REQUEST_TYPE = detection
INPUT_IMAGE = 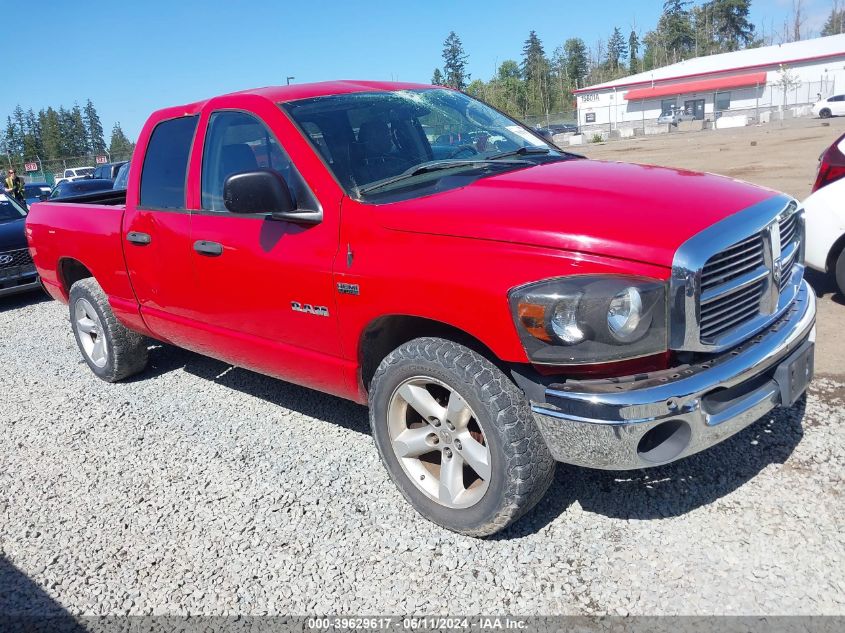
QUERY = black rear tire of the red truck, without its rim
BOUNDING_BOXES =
[68,277,147,382]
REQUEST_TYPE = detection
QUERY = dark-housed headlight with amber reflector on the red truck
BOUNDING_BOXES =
[509,275,667,365]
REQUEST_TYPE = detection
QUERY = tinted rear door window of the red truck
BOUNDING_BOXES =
[140,116,198,209]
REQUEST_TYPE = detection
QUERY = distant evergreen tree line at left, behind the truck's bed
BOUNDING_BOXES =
[0,99,135,163]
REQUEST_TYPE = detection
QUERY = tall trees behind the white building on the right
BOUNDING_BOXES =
[431,0,845,118]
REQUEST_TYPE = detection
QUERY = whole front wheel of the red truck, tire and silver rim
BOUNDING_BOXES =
[370,338,554,536]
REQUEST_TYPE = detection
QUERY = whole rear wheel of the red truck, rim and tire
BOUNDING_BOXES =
[68,277,147,382]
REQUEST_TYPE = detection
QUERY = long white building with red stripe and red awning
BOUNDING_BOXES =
[575,35,845,131]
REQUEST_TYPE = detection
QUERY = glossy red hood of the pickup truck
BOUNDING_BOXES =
[375,160,777,266]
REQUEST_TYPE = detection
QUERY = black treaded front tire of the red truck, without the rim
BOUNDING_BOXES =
[370,338,555,537]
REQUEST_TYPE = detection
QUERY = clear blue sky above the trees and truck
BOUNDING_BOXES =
[0,0,830,142]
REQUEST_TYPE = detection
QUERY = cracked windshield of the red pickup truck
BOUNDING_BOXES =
[281,88,562,196]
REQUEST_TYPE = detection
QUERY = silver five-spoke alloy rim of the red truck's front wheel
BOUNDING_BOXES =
[387,376,491,508]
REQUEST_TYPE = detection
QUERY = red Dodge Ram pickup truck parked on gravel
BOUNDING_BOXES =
[27,81,815,536]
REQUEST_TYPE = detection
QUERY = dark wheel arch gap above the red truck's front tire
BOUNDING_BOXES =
[358,314,506,394]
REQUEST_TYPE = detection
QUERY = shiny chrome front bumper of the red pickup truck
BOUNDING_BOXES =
[532,281,816,470]
